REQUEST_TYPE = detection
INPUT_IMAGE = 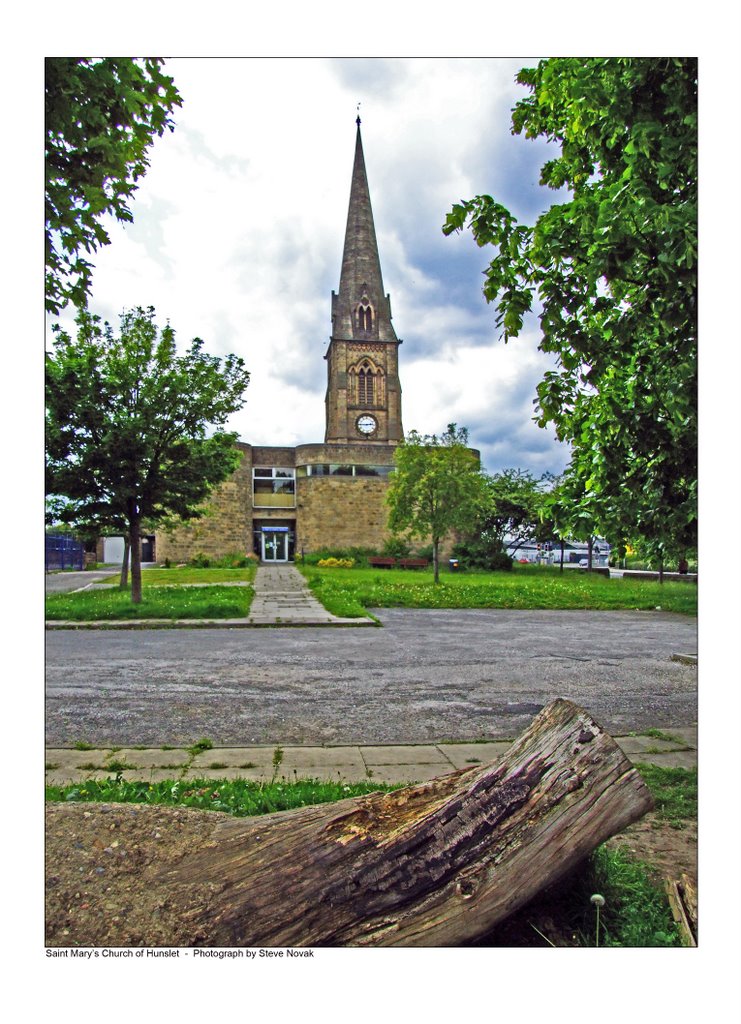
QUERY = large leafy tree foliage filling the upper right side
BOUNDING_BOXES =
[443,57,697,550]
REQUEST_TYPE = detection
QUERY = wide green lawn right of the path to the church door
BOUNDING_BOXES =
[298,565,697,617]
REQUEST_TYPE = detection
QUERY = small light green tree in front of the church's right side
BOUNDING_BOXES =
[386,423,484,583]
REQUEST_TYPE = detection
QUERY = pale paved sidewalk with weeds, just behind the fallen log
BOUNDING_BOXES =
[46,727,697,785]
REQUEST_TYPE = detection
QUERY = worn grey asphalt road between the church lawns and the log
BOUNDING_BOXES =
[46,608,697,746]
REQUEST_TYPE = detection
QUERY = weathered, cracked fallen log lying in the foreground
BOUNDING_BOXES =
[161,700,653,946]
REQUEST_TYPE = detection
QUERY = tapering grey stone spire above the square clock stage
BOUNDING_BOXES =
[333,117,397,341]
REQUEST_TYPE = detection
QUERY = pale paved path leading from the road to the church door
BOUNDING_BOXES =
[247,564,375,626]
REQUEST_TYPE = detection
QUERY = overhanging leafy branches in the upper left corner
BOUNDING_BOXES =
[45,57,182,313]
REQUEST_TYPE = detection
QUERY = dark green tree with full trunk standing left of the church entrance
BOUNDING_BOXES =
[46,306,250,603]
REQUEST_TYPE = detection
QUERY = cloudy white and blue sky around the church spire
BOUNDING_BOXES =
[52,57,568,474]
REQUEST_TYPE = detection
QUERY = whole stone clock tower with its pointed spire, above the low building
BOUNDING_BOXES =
[324,118,404,445]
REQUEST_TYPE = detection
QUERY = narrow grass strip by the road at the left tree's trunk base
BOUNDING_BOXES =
[46,586,253,623]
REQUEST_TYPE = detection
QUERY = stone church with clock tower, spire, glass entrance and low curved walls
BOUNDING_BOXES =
[156,124,403,562]
